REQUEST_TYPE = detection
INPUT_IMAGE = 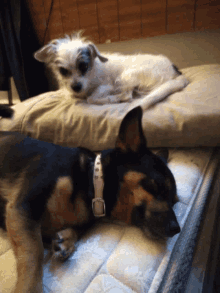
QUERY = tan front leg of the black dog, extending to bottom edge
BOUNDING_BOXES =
[6,203,44,293]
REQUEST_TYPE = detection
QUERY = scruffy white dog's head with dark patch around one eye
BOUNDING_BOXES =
[34,33,108,99]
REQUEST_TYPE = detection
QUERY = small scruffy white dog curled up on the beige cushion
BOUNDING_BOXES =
[34,33,188,107]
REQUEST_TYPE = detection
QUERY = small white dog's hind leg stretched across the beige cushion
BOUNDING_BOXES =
[141,75,189,110]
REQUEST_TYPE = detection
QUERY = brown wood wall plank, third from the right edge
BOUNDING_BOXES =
[141,0,166,37]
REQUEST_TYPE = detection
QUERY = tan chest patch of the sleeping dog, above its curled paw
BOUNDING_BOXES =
[42,176,89,234]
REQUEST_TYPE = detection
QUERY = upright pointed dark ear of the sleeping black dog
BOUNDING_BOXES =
[115,106,146,153]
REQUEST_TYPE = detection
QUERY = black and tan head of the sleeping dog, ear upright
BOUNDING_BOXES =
[102,107,180,238]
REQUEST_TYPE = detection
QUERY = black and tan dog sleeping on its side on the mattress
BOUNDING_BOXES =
[0,107,180,293]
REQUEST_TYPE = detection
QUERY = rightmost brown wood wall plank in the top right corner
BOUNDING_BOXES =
[195,0,220,30]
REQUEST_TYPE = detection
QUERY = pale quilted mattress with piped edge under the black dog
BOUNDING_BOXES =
[0,148,219,293]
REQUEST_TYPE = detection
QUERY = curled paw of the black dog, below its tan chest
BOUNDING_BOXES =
[52,228,77,261]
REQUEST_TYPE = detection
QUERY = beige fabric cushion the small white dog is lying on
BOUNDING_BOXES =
[0,64,220,151]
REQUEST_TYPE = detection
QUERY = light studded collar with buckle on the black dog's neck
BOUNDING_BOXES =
[92,154,105,217]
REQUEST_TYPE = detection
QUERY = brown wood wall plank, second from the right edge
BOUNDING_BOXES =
[167,0,195,34]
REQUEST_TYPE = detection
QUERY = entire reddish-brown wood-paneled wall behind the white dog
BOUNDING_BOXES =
[27,0,220,45]
